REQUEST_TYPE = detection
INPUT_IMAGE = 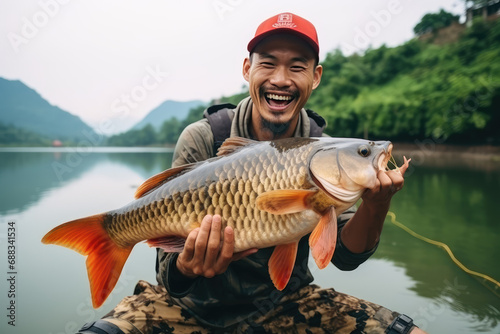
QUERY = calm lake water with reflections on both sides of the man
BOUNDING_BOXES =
[0,148,500,334]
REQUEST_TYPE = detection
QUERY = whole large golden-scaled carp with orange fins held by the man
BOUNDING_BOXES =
[42,137,402,308]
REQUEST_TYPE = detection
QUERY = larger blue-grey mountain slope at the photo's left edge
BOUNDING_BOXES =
[0,78,96,144]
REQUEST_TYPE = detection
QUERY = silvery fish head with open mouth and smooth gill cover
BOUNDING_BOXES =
[309,138,393,203]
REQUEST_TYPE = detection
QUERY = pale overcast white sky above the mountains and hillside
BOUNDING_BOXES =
[0,0,464,131]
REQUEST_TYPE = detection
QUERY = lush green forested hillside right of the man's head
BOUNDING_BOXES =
[308,19,500,143]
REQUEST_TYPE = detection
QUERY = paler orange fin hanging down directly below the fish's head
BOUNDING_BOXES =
[309,206,337,269]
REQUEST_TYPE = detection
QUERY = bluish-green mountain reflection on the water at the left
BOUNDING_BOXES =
[0,151,172,214]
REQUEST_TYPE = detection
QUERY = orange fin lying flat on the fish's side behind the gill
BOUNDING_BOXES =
[256,189,316,215]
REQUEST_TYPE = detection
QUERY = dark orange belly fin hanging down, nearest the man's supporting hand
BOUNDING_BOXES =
[269,242,299,291]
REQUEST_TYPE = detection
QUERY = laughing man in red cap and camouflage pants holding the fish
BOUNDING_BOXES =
[80,13,423,333]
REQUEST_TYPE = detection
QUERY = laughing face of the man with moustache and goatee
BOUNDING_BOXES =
[243,34,323,137]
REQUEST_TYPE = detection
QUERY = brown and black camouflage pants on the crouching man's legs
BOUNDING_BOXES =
[103,281,398,334]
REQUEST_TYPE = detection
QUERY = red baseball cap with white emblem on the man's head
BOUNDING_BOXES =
[247,13,319,58]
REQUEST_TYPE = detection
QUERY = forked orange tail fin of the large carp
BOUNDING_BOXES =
[42,214,133,308]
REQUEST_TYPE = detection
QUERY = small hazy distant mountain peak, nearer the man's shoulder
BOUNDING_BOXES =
[132,100,205,130]
